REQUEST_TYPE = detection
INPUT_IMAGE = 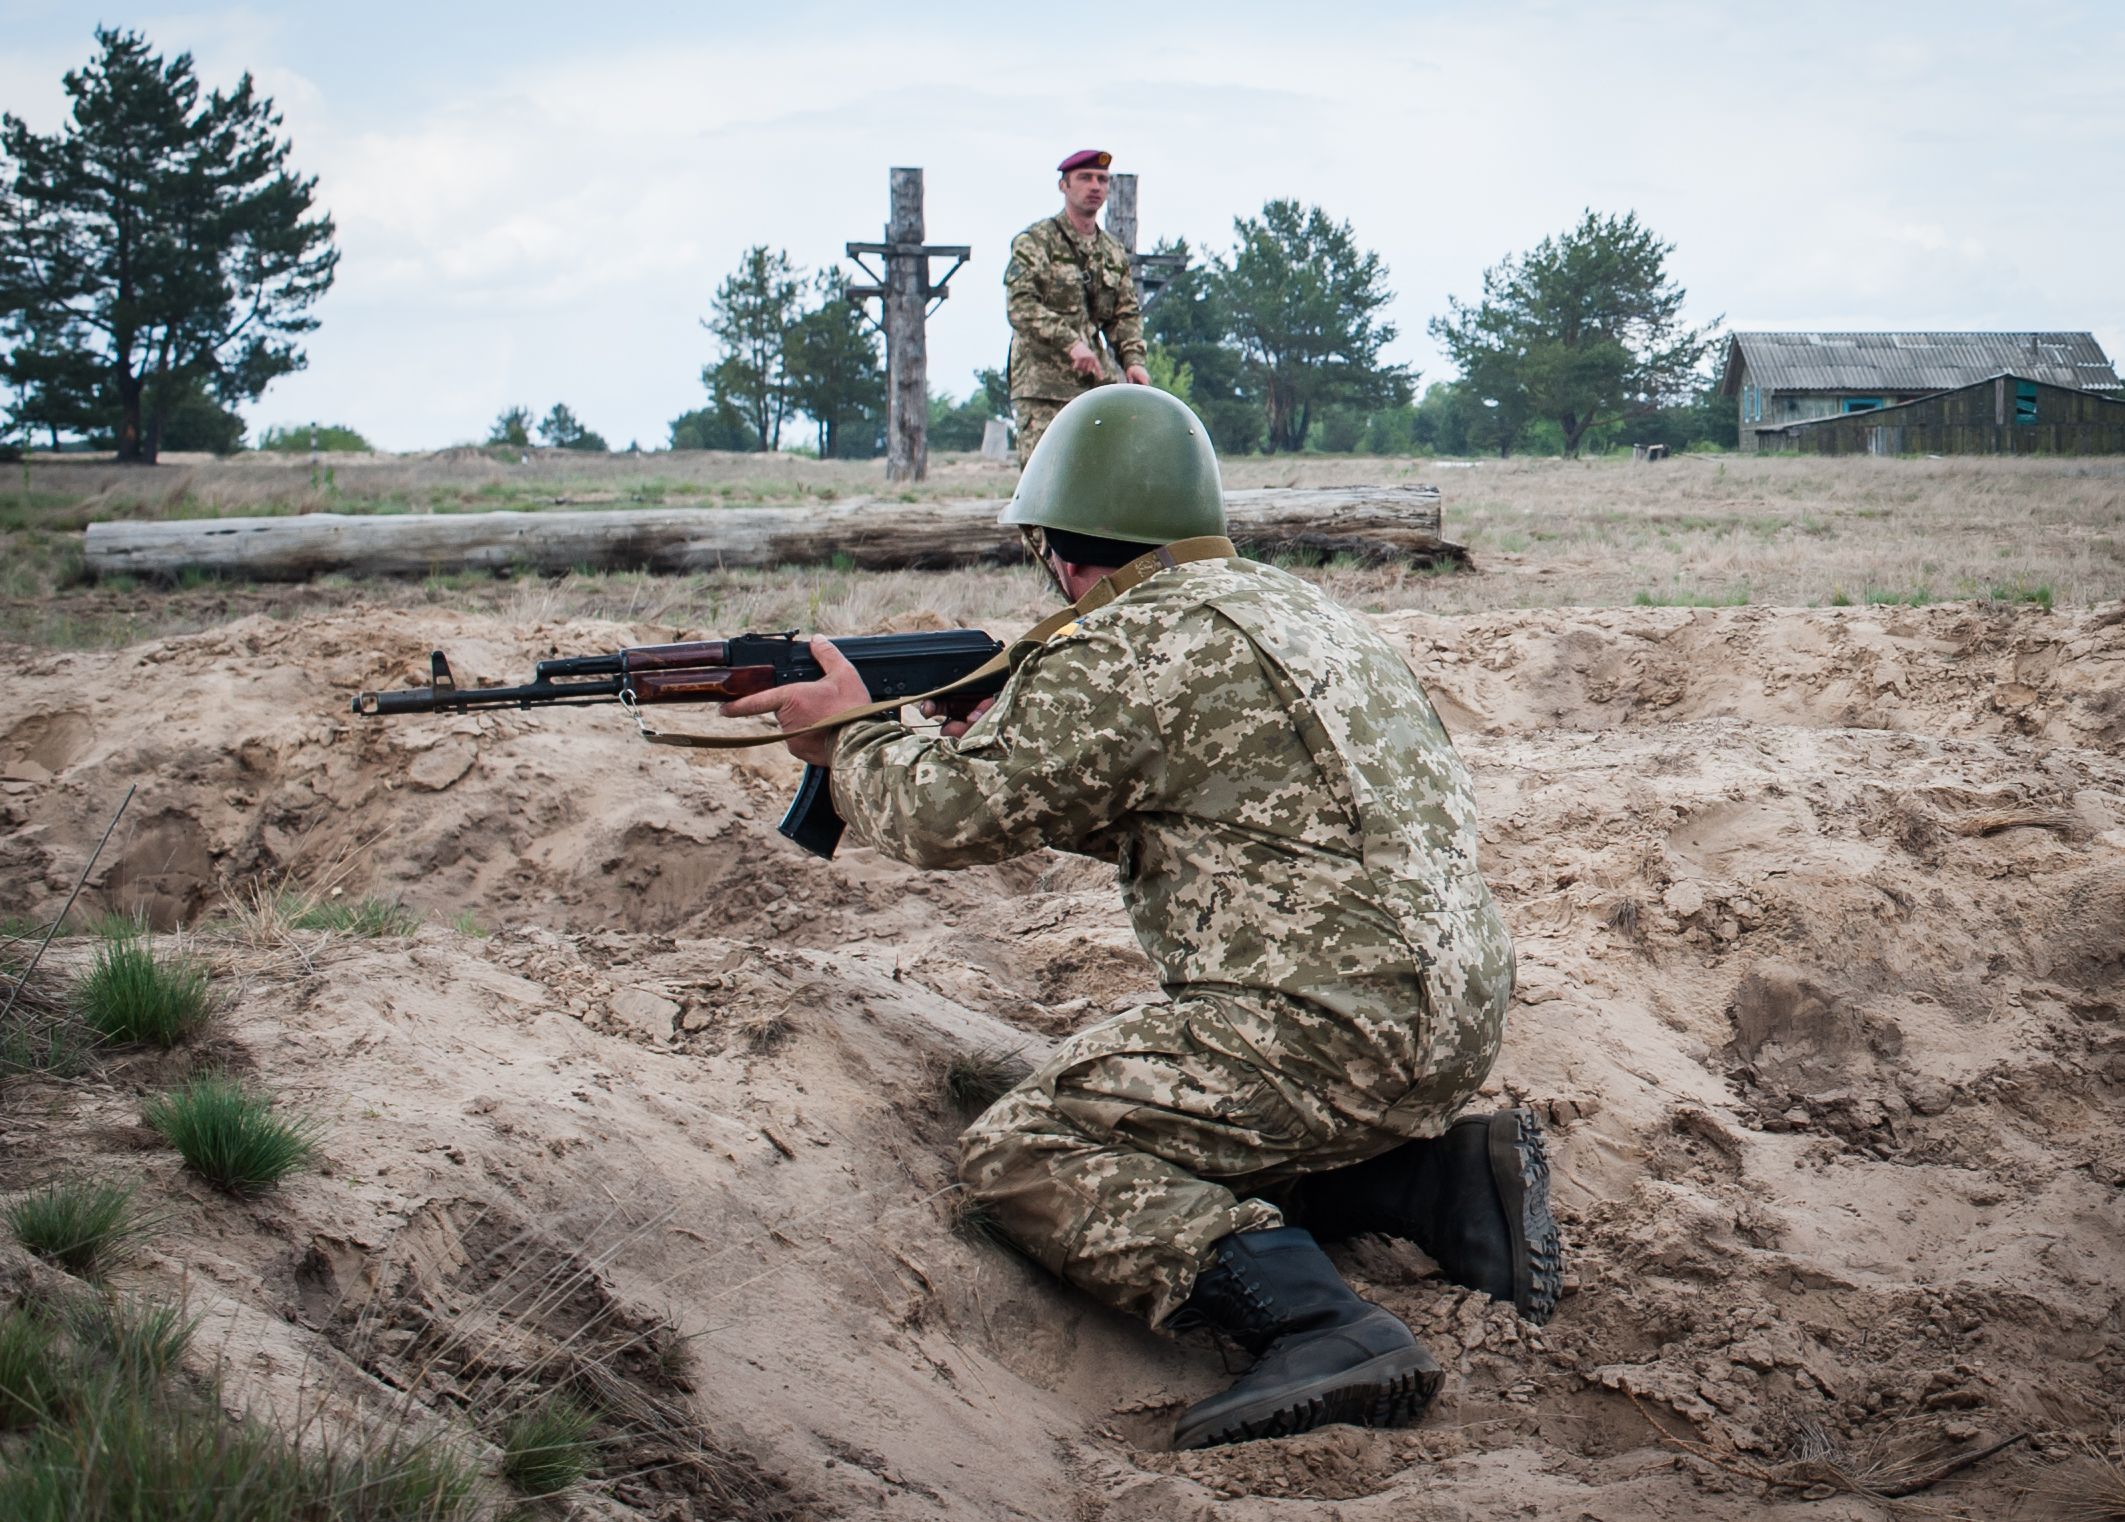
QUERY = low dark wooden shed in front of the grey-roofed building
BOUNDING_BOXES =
[1757,372,2125,455]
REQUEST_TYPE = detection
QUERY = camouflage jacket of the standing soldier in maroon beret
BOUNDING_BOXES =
[1003,213,1143,402]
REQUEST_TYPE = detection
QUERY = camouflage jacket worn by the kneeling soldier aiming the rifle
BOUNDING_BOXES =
[833,559,1513,1135]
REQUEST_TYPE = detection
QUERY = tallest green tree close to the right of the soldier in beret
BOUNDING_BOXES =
[1215,200,1413,453]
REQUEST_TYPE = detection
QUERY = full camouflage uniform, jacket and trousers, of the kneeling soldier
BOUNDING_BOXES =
[833,559,1513,1324]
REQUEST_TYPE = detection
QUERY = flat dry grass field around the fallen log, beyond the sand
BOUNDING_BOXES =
[0,451,2125,648]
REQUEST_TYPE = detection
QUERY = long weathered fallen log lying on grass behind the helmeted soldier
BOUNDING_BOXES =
[85,487,1466,580]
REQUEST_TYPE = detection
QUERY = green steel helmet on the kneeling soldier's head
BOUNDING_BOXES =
[999,385,1224,544]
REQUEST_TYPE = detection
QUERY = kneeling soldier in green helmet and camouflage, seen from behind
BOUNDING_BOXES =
[725,387,1562,1448]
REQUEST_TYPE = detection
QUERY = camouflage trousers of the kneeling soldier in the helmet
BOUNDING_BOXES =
[958,997,1462,1326]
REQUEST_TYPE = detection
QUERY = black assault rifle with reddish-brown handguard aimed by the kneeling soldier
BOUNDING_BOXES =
[355,629,1005,857]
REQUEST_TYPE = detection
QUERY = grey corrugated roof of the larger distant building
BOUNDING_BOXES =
[1721,334,2119,393]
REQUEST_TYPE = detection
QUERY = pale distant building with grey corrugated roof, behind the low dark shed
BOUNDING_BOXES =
[1719,334,2125,455]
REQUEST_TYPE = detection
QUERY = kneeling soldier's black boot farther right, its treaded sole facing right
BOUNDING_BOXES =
[1292,1110,1564,1324]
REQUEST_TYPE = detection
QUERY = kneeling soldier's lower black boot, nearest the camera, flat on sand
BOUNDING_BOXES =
[1167,1227,1441,1448]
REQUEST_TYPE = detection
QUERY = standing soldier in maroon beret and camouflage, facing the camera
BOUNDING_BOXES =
[1003,149,1152,466]
